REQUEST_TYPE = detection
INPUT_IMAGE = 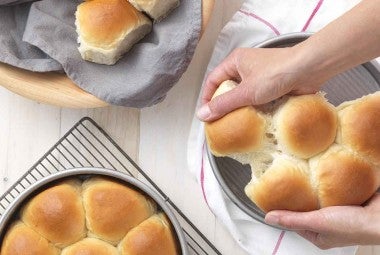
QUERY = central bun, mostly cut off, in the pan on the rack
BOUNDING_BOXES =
[61,238,119,255]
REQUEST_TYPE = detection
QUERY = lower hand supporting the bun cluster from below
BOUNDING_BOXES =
[265,193,380,249]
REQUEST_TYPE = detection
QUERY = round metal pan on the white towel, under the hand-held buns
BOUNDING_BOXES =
[206,33,380,227]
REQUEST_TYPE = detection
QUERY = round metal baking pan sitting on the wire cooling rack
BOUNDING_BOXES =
[0,167,189,255]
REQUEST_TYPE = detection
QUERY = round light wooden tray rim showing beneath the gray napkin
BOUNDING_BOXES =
[0,0,214,108]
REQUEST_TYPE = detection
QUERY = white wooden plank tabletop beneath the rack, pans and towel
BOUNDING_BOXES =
[0,0,380,255]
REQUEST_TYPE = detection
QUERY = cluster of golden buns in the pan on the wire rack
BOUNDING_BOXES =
[0,177,178,255]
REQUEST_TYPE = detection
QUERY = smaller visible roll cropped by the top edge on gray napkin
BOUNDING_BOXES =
[128,0,179,21]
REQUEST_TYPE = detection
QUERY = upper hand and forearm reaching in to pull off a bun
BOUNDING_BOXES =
[197,0,380,121]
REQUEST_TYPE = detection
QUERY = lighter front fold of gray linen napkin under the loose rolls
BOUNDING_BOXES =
[0,0,201,108]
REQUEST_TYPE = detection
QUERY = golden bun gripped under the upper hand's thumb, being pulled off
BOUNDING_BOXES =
[205,81,265,156]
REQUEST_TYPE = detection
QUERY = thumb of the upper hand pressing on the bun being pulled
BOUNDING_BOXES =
[197,84,252,121]
